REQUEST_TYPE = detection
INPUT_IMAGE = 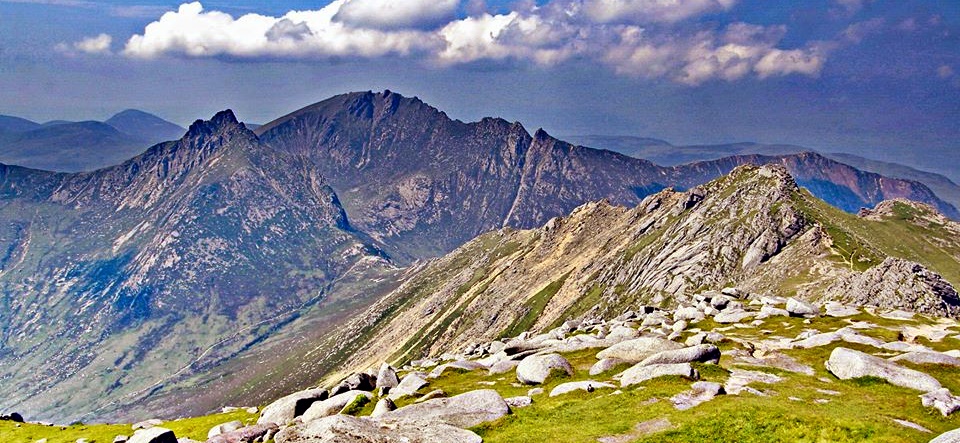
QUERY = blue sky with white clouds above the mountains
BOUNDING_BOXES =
[0,0,960,177]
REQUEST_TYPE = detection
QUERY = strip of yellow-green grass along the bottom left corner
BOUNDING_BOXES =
[0,410,257,443]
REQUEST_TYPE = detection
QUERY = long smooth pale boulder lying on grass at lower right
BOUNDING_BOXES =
[825,348,940,392]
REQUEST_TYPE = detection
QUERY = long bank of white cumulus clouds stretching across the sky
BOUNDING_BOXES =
[97,0,836,85]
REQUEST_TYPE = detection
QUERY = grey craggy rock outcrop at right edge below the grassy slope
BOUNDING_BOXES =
[825,258,960,317]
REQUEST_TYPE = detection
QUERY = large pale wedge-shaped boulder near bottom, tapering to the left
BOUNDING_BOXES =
[377,389,510,428]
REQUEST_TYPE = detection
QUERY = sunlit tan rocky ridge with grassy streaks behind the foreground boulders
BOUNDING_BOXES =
[316,166,960,380]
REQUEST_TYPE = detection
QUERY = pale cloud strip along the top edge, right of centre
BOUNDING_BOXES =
[582,0,737,23]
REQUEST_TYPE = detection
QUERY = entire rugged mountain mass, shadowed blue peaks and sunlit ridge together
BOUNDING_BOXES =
[0,91,958,420]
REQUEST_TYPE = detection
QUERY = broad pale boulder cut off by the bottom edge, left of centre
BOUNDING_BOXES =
[274,415,483,443]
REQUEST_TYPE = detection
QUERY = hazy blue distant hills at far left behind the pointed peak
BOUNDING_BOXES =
[0,110,186,172]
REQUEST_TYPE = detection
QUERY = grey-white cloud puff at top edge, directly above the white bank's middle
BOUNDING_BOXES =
[333,0,460,29]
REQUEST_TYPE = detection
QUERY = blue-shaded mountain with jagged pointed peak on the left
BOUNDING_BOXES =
[0,112,389,420]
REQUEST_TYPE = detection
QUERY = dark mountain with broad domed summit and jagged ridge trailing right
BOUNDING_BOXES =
[257,91,956,258]
